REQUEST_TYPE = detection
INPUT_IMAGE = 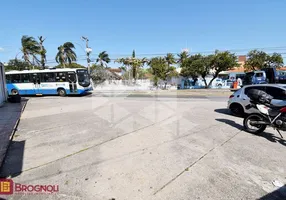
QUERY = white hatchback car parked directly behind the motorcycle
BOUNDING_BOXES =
[227,84,286,116]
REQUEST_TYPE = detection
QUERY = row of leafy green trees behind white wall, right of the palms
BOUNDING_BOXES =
[115,50,284,88]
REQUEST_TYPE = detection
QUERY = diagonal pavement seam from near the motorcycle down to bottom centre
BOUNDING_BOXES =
[153,130,242,195]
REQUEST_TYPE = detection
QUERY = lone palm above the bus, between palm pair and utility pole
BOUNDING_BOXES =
[56,42,77,68]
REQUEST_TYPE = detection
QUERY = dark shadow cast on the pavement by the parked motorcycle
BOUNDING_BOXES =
[216,119,286,146]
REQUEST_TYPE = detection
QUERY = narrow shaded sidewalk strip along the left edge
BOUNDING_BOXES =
[0,99,28,168]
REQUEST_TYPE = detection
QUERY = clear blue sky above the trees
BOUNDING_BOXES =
[0,0,286,67]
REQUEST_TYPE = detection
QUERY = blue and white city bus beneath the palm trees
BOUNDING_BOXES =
[5,68,92,96]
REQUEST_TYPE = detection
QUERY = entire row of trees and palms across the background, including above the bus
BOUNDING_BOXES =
[3,36,284,87]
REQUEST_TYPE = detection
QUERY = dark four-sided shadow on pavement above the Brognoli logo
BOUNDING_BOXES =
[0,141,25,178]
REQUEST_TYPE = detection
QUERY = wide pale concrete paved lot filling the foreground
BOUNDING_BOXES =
[2,93,286,200]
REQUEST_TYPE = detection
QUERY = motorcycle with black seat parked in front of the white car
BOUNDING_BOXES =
[243,89,286,138]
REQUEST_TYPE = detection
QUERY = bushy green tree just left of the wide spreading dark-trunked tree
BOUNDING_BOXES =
[149,57,178,89]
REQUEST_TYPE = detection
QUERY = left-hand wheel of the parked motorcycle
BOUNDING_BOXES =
[243,114,267,134]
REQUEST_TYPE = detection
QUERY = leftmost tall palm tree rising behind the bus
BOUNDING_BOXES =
[21,35,41,65]
